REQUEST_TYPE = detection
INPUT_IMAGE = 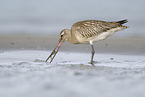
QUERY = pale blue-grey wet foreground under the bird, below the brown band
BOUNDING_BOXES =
[0,50,145,97]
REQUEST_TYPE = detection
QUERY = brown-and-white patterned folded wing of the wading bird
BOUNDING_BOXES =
[71,20,121,38]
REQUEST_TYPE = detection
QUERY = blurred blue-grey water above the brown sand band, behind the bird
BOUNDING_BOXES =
[0,0,145,37]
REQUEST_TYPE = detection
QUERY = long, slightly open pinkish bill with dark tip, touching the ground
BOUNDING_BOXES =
[45,39,63,63]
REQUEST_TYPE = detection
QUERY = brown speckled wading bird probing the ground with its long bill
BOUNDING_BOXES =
[45,19,128,65]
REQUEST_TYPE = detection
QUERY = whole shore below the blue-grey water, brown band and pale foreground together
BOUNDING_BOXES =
[0,35,145,97]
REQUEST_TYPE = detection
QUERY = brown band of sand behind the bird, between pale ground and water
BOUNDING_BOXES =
[0,35,145,55]
